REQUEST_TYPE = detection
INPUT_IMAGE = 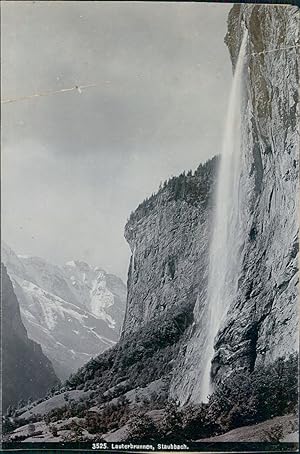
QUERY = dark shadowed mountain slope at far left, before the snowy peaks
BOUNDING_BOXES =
[1,263,58,411]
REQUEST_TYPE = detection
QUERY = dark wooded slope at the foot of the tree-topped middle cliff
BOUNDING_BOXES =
[66,298,193,394]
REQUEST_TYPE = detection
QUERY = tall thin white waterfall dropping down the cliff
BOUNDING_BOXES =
[200,31,247,402]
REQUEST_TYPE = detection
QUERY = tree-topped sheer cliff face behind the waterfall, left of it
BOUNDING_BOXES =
[123,158,217,335]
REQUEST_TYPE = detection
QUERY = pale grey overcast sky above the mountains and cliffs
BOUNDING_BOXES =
[2,1,231,279]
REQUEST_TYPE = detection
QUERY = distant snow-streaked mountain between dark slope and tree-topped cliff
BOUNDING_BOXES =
[2,243,126,379]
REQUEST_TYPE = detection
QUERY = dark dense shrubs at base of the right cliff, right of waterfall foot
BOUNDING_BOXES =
[208,355,298,430]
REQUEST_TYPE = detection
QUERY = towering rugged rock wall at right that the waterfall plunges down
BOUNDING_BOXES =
[171,5,299,403]
